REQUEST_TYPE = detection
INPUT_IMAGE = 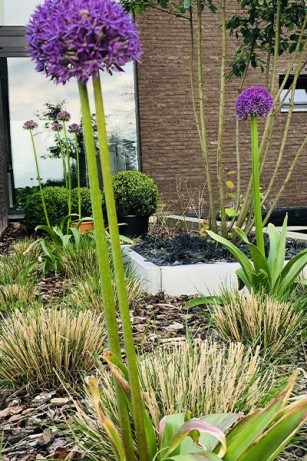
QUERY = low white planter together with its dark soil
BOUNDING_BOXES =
[124,233,307,296]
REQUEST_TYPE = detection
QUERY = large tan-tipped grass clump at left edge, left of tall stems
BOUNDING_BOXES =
[0,308,105,389]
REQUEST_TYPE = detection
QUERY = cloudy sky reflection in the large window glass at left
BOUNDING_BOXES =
[8,58,138,199]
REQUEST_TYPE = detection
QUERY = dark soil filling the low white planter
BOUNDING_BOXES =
[133,232,307,266]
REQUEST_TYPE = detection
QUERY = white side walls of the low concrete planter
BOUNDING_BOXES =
[123,247,240,296]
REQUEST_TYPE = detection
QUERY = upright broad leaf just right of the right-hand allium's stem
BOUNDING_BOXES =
[268,215,288,286]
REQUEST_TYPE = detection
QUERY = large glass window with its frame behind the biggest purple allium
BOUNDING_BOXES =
[0,0,139,207]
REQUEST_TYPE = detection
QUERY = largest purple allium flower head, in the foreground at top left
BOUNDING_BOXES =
[27,0,141,83]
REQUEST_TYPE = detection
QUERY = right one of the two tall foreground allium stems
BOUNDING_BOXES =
[93,76,151,461]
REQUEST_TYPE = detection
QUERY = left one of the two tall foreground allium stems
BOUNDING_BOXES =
[78,81,135,461]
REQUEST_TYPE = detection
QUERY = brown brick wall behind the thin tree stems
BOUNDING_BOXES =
[137,4,307,211]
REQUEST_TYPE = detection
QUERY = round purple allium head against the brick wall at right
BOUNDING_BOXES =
[236,86,274,120]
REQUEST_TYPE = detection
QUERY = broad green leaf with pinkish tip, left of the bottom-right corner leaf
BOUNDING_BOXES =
[223,372,297,461]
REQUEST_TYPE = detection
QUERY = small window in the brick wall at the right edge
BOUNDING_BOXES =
[279,75,307,112]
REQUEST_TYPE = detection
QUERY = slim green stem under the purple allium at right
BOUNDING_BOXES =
[251,115,265,255]
